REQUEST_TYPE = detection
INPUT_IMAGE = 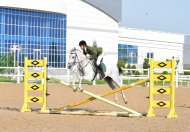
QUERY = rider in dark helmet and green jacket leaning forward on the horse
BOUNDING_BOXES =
[79,40,105,80]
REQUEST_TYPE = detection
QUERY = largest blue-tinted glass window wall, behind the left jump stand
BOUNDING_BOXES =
[0,7,66,67]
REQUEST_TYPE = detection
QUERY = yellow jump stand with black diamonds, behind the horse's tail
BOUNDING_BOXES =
[147,58,177,118]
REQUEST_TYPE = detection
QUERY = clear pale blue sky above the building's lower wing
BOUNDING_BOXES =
[121,0,190,35]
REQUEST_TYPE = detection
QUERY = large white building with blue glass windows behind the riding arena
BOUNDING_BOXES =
[0,0,184,68]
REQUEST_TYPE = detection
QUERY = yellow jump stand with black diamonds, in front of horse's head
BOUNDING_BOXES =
[20,57,49,112]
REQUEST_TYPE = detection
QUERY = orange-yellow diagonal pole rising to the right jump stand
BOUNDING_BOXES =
[56,79,149,111]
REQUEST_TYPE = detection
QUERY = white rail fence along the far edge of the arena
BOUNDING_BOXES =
[0,67,190,87]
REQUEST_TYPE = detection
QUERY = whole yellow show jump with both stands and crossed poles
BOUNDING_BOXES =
[21,58,177,118]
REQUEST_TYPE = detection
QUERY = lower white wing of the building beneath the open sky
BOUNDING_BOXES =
[118,28,184,69]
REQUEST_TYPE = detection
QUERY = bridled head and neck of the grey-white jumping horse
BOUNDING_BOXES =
[67,48,85,69]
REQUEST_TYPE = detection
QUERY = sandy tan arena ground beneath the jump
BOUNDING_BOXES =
[0,83,190,132]
